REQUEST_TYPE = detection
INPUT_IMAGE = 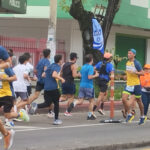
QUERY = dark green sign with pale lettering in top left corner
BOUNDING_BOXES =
[0,0,27,14]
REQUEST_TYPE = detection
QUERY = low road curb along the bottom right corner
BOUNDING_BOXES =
[72,141,150,150]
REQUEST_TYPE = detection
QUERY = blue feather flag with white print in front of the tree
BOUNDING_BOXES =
[92,19,104,54]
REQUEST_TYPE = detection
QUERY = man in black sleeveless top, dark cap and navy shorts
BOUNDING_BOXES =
[59,53,81,116]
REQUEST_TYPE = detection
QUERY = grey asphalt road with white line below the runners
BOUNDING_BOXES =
[0,111,150,150]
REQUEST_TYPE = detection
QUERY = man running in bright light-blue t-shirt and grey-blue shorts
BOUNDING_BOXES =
[67,54,99,120]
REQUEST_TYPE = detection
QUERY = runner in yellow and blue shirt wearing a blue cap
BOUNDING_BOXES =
[122,49,146,125]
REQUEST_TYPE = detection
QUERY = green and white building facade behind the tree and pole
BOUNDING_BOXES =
[0,0,150,69]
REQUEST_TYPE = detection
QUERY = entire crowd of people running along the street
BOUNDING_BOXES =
[0,46,150,149]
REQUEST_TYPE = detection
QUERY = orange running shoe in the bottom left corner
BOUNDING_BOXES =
[4,129,15,150]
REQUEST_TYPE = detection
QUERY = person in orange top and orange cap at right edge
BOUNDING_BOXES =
[140,64,150,118]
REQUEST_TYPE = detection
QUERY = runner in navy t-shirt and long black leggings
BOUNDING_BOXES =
[31,55,65,125]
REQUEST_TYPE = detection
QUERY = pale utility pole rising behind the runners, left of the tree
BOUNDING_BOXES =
[47,0,57,63]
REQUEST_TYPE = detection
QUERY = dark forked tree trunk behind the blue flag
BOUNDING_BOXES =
[69,0,121,63]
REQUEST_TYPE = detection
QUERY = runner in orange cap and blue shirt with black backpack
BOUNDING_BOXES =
[93,52,114,115]
